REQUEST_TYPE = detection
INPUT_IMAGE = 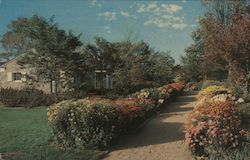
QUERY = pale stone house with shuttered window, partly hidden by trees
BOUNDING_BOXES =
[0,59,113,93]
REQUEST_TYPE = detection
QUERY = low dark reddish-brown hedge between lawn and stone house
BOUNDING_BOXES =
[0,88,56,107]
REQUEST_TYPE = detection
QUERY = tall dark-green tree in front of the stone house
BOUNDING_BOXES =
[2,15,81,93]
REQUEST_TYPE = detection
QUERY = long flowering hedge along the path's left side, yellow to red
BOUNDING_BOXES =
[48,83,184,149]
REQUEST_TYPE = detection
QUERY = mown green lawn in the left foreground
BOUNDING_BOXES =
[0,107,103,160]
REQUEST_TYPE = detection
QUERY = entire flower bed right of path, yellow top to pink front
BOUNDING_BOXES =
[186,86,246,158]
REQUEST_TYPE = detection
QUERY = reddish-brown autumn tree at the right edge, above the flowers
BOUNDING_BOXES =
[201,0,249,93]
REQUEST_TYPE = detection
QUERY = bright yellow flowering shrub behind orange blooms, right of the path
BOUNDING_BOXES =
[196,86,232,100]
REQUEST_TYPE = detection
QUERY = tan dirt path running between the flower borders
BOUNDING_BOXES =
[104,92,195,160]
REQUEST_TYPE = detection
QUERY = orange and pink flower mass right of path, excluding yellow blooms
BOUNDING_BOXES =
[186,102,245,155]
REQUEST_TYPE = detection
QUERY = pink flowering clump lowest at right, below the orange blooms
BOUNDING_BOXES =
[186,115,245,155]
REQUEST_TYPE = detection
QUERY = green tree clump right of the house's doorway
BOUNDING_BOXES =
[110,41,174,95]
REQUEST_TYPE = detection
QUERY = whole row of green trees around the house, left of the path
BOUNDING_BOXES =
[0,15,175,94]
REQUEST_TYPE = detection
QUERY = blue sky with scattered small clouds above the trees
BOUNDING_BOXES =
[0,0,204,63]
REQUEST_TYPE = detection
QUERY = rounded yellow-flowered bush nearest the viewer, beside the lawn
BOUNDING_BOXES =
[48,99,126,149]
